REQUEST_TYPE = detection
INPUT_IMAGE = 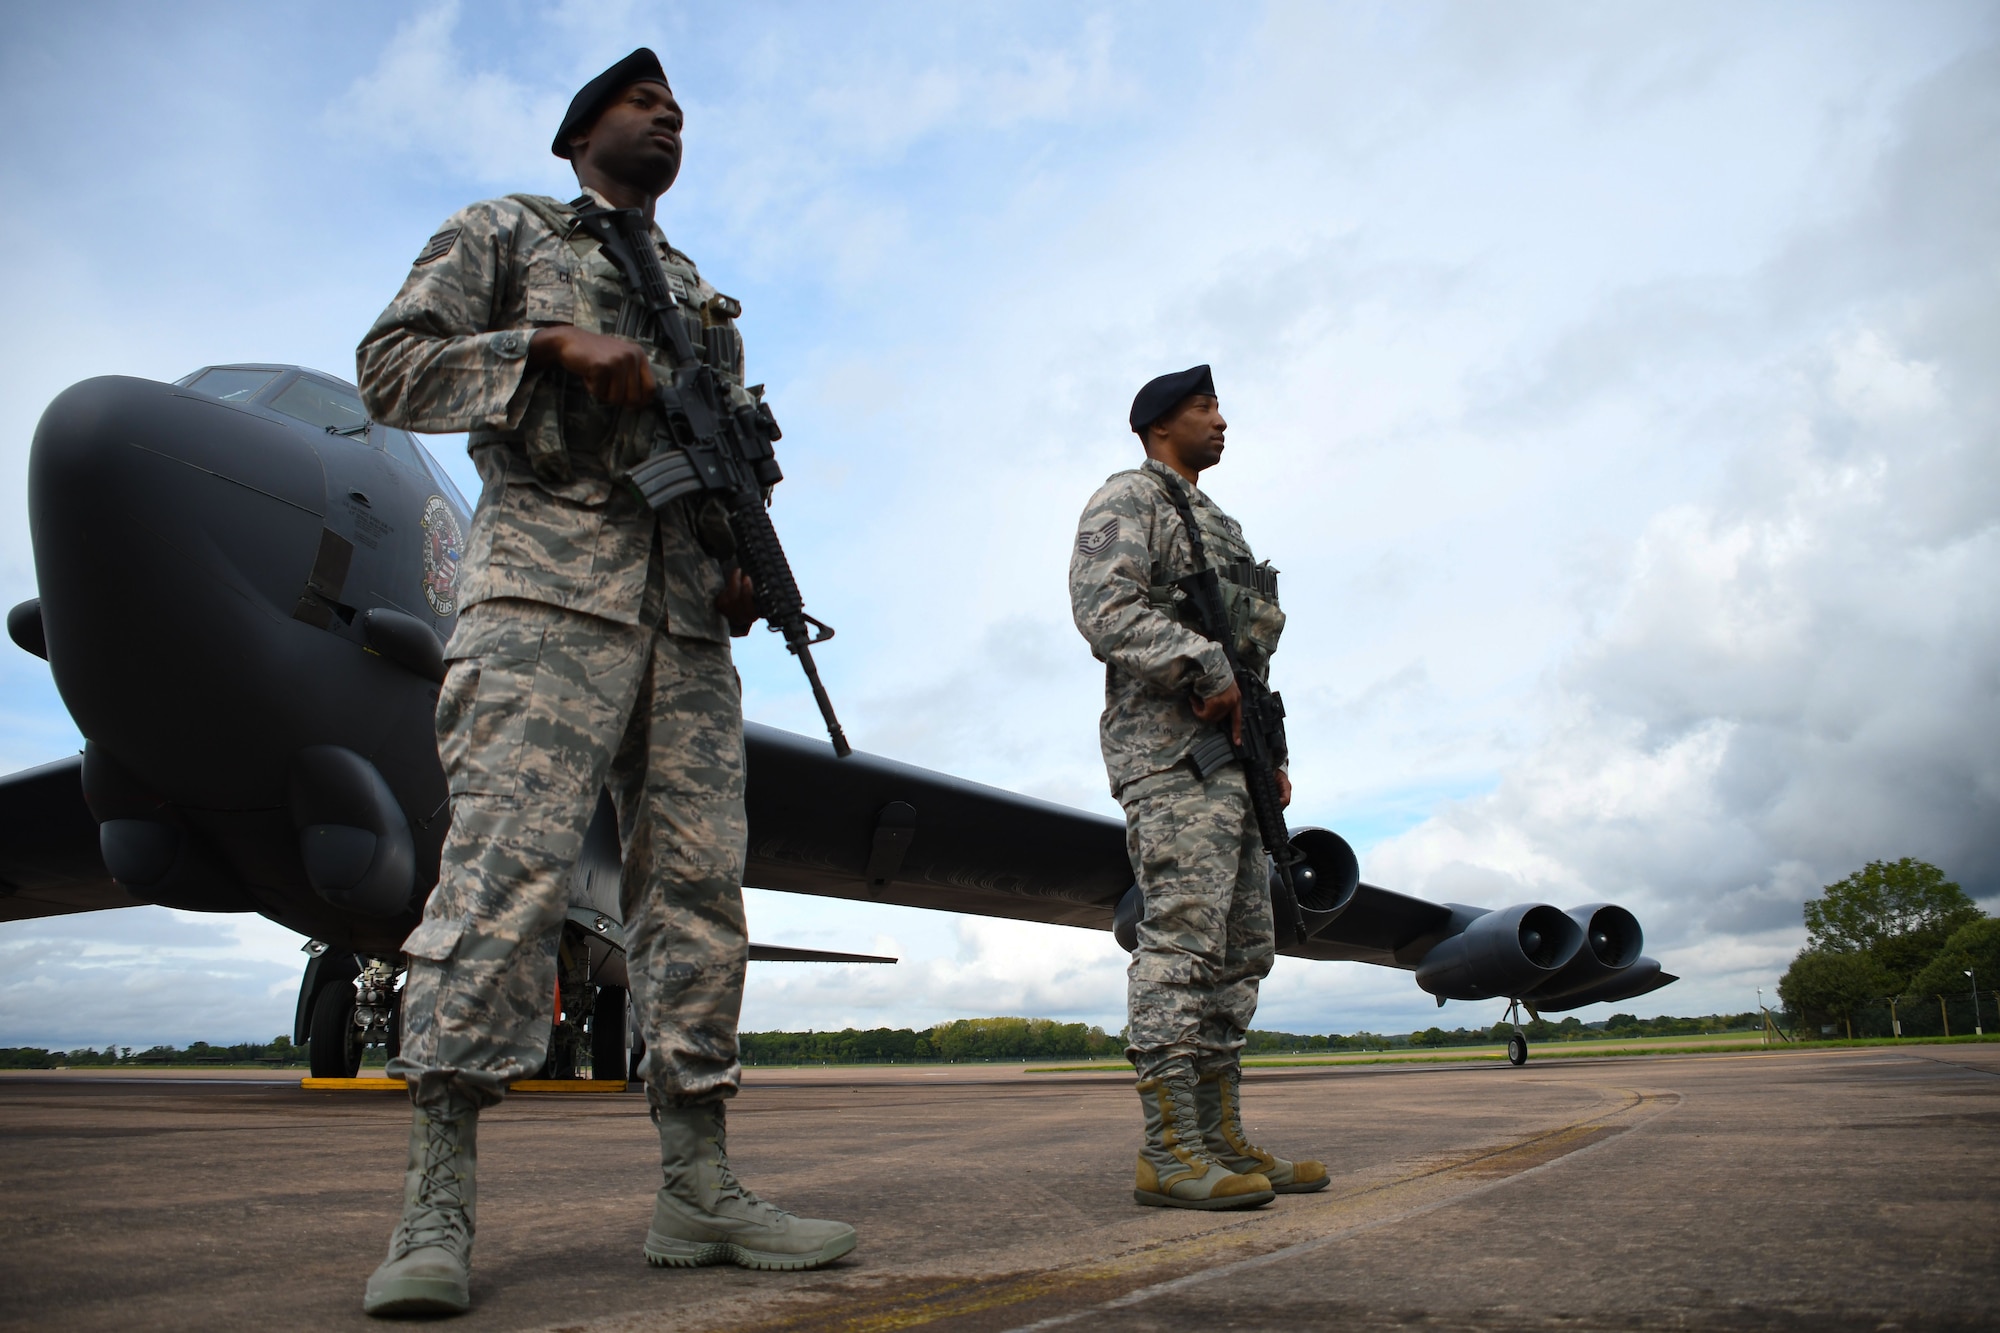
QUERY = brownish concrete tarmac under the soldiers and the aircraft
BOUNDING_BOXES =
[0,1045,2000,1333]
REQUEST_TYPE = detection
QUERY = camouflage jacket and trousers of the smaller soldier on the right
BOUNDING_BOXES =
[1070,458,1284,1079]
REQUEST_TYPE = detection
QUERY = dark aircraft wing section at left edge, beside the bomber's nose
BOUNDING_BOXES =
[0,755,138,921]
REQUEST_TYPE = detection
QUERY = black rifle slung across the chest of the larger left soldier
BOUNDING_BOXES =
[574,196,854,759]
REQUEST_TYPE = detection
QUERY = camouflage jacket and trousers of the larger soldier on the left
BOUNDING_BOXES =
[356,184,748,1105]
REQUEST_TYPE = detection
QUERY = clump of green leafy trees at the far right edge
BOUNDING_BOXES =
[1778,857,2000,1037]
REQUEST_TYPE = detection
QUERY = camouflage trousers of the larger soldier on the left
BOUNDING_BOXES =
[390,598,750,1105]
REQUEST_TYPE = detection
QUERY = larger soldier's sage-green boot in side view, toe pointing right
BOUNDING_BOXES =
[646,1103,854,1271]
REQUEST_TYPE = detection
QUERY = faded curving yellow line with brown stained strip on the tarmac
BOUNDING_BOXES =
[696,1089,1680,1333]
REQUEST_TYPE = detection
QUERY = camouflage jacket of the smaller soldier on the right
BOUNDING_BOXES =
[1070,458,1284,797]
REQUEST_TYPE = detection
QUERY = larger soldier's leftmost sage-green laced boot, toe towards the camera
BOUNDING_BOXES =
[362,1099,480,1315]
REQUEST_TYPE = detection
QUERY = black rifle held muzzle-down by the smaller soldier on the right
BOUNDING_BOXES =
[1162,478,1316,947]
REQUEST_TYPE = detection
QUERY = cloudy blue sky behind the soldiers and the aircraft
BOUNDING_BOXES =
[0,4,2000,1045]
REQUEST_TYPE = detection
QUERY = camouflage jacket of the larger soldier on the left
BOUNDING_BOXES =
[356,196,742,640]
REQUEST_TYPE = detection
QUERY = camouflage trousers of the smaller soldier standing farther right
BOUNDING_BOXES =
[1118,765,1276,1079]
